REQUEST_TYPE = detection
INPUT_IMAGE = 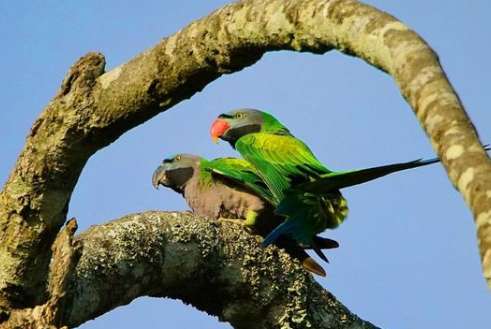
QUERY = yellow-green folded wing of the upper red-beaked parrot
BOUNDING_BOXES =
[235,133,331,200]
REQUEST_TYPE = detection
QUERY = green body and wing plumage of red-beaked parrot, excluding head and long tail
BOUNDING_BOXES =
[235,114,348,245]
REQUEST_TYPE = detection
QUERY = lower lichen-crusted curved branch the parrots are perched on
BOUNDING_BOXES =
[66,212,375,328]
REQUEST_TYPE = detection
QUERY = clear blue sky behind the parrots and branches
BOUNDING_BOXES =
[0,0,491,329]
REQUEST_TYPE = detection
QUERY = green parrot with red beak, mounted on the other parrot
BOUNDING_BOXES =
[210,109,446,250]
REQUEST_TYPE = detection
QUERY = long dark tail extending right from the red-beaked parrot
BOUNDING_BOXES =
[295,158,440,194]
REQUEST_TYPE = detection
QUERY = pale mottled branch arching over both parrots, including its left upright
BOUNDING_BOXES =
[0,0,491,326]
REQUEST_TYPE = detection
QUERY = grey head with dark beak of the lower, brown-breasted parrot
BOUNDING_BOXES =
[152,154,201,192]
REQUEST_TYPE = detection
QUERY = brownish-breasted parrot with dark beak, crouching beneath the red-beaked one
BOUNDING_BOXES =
[152,154,338,276]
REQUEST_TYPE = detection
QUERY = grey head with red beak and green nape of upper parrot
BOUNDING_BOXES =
[210,109,288,146]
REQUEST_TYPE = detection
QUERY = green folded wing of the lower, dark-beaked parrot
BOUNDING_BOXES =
[202,158,273,204]
